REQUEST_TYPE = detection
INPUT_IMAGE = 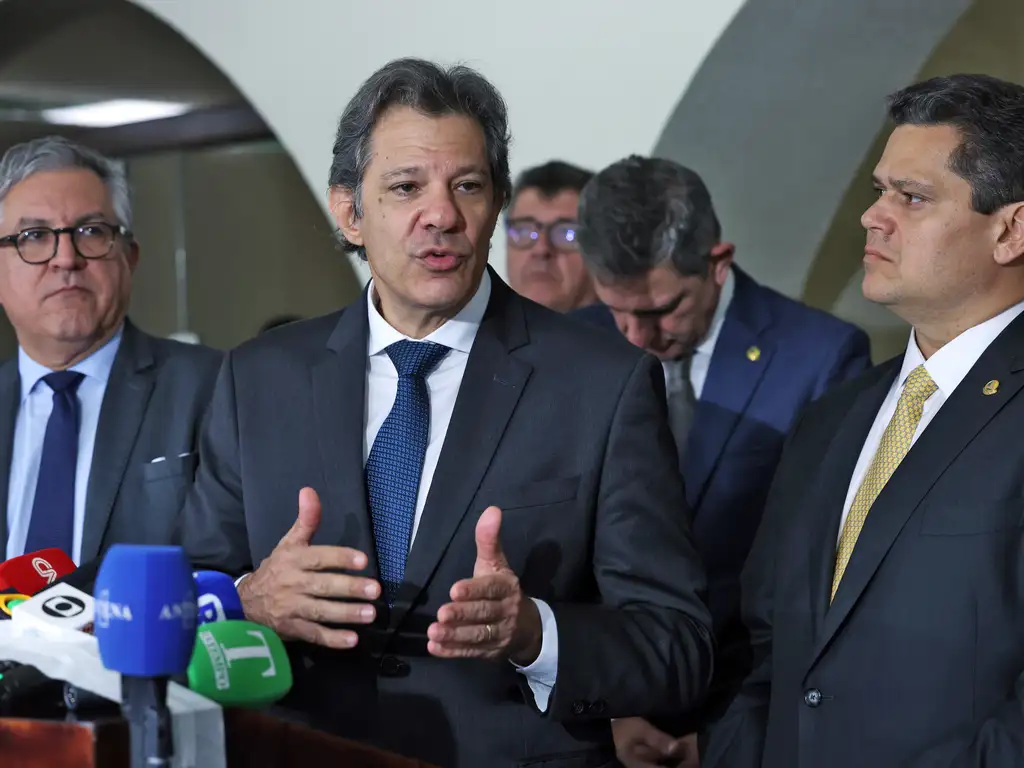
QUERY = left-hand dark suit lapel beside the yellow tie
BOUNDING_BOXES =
[807,357,903,633]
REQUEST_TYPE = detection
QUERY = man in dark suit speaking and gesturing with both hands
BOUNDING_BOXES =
[184,59,711,768]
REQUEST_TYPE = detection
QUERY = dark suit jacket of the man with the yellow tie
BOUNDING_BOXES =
[705,309,1024,768]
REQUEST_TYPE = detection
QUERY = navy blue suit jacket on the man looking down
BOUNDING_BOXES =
[573,267,870,732]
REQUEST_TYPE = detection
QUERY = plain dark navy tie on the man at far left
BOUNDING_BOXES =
[25,371,83,556]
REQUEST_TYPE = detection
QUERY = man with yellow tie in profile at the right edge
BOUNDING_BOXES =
[703,75,1024,768]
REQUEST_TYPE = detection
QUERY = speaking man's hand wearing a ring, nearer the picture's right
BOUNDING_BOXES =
[427,507,543,667]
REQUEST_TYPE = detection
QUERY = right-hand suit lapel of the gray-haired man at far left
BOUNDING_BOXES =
[81,321,156,562]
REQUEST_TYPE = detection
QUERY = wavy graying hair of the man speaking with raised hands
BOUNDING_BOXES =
[329,58,512,259]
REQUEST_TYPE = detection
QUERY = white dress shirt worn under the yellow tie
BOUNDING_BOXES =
[837,302,1024,542]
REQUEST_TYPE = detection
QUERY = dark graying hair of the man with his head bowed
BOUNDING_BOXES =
[577,155,722,281]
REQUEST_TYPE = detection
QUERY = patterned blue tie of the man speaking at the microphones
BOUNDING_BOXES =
[367,341,449,605]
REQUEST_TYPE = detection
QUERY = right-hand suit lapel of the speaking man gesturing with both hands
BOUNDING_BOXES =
[390,273,531,629]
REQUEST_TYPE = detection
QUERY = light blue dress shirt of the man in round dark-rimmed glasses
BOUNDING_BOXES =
[7,328,124,564]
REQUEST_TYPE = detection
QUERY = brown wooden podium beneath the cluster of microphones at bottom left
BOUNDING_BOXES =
[0,710,432,768]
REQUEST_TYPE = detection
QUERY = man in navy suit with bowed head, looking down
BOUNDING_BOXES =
[577,156,870,768]
